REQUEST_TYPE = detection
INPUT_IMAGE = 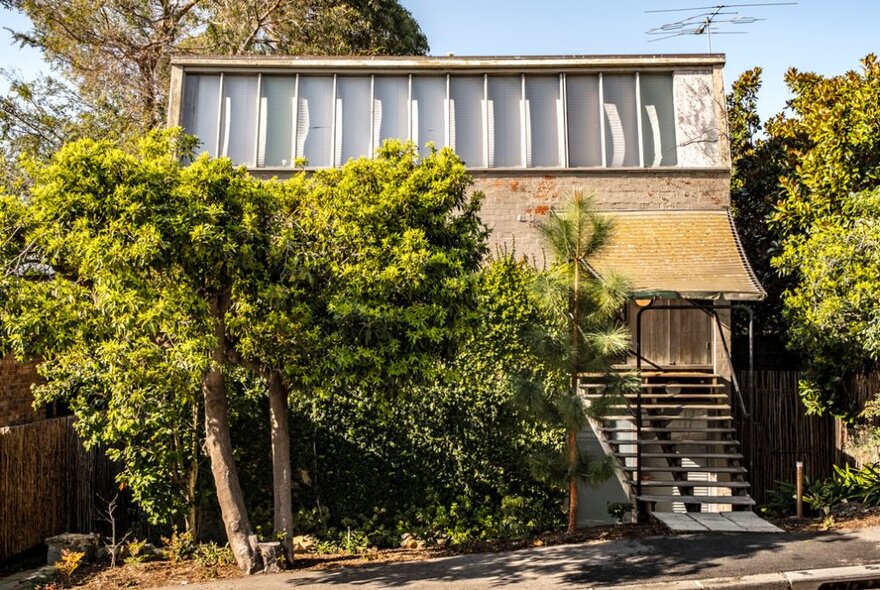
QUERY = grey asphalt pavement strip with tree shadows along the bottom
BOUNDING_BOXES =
[151,528,880,590]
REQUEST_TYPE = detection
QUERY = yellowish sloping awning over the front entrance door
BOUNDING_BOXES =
[590,209,767,301]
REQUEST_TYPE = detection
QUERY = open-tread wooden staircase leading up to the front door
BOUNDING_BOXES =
[581,370,755,512]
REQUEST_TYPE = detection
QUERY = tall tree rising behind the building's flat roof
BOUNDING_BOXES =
[3,0,428,132]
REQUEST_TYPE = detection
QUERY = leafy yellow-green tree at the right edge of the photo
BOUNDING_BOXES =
[769,55,880,415]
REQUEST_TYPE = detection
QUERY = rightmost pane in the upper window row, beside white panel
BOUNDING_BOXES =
[639,74,678,166]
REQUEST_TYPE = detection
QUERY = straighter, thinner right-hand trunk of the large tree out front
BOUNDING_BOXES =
[269,373,293,566]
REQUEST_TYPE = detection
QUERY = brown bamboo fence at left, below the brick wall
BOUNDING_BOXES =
[0,416,129,561]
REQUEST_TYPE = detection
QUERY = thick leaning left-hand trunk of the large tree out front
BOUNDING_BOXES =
[202,296,261,574]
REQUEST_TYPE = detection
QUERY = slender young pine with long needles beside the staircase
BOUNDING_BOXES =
[527,192,632,534]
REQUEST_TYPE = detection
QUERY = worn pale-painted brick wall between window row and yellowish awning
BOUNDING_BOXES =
[474,169,730,265]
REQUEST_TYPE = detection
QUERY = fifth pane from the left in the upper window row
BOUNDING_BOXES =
[336,77,372,166]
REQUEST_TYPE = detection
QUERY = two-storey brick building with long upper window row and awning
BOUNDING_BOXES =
[169,55,764,524]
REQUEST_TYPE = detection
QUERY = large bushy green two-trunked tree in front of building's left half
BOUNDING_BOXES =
[3,132,485,571]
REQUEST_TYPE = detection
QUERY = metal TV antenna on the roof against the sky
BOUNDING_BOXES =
[645,2,797,53]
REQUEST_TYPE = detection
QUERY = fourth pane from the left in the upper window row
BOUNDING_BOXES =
[296,76,333,168]
